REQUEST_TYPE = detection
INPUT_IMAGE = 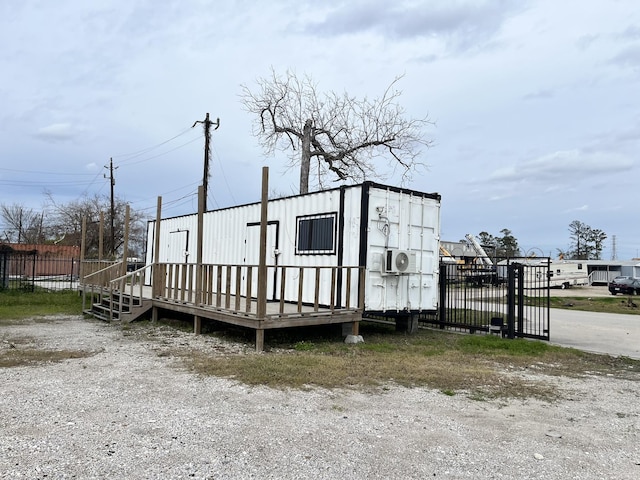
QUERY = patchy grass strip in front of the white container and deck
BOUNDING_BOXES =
[149,323,640,401]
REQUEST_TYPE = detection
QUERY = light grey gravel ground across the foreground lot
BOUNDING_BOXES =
[0,317,640,479]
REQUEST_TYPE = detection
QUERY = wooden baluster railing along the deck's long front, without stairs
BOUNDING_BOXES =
[154,263,364,316]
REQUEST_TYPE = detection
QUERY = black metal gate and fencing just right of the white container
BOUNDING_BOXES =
[422,258,551,340]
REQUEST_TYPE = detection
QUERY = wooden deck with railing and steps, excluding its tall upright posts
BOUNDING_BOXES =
[81,264,364,351]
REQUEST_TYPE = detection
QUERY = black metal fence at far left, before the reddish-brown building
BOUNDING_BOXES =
[0,252,80,291]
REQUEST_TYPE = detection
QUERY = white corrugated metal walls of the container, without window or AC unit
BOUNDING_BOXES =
[147,184,440,312]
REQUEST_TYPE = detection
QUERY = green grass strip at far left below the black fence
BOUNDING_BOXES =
[0,290,82,326]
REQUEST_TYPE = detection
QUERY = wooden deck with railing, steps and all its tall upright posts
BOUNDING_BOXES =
[80,178,365,351]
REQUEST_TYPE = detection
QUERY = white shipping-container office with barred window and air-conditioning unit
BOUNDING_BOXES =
[146,182,440,316]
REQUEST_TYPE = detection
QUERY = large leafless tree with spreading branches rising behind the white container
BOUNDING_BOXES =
[240,70,432,193]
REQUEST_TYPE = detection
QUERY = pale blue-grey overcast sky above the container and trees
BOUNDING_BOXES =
[0,0,640,259]
